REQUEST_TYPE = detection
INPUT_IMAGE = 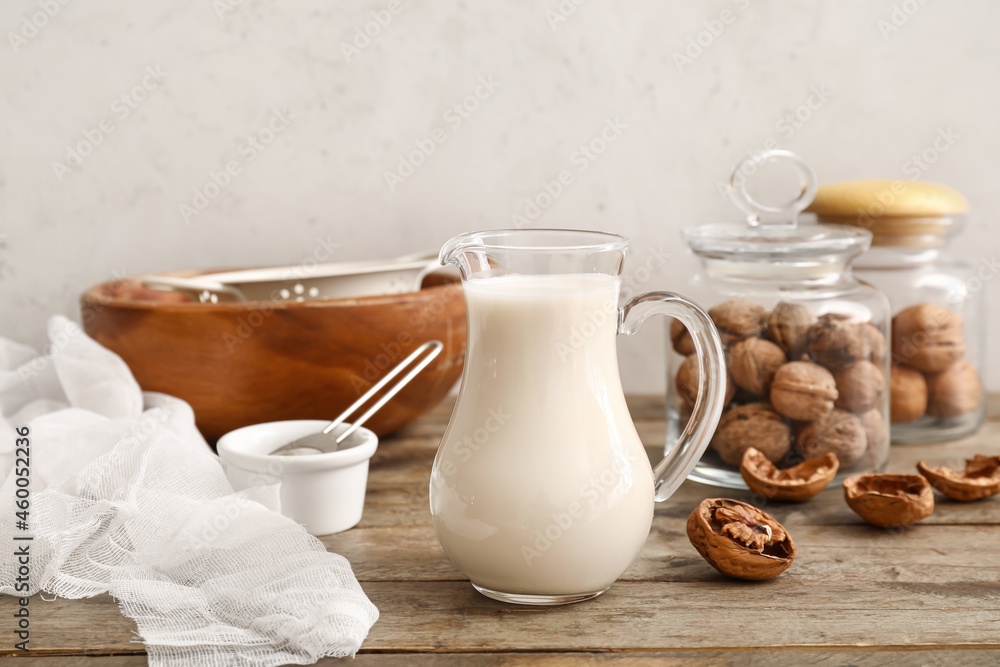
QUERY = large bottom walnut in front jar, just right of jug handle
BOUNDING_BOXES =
[712,403,792,466]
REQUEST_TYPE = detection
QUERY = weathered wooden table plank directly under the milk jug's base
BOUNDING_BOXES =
[7,569,1000,655]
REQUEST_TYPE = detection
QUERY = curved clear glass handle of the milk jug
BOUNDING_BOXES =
[618,292,726,501]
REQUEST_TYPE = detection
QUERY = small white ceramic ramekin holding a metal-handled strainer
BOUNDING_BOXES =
[217,419,378,535]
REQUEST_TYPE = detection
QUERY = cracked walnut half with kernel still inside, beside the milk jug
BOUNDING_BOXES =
[687,498,796,581]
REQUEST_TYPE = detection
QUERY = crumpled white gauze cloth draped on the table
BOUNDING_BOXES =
[0,317,378,666]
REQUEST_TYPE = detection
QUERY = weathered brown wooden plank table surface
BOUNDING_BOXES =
[0,395,1000,667]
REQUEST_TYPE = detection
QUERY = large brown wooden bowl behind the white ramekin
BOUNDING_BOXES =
[80,272,465,442]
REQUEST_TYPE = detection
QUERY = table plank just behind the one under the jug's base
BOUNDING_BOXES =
[324,518,1000,584]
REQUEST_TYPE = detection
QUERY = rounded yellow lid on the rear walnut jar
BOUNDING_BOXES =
[806,179,969,246]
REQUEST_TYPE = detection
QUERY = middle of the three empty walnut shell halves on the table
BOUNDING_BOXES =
[844,473,934,527]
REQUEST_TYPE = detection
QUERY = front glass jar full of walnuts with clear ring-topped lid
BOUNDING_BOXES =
[667,150,889,488]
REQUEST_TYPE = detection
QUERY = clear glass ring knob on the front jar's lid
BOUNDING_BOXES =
[728,149,818,229]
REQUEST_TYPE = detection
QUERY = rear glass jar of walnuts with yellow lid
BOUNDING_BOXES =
[807,180,986,442]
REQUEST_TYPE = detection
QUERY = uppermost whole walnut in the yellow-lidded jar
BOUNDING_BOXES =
[892,303,965,373]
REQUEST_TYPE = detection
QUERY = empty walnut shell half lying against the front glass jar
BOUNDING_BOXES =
[740,447,840,502]
